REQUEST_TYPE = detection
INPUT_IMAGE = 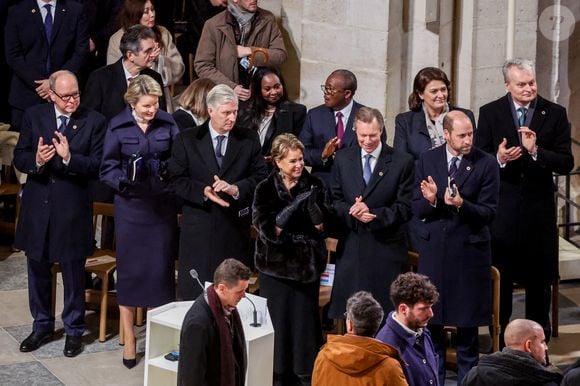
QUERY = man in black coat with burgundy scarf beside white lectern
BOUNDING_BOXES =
[177,259,251,386]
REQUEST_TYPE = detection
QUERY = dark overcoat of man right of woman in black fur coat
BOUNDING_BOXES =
[329,144,414,318]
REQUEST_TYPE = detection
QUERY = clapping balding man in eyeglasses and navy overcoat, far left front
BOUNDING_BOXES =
[14,71,106,357]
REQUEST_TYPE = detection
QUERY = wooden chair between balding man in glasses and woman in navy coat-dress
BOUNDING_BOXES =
[52,202,117,342]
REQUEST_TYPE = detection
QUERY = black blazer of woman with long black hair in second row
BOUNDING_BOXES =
[237,101,306,155]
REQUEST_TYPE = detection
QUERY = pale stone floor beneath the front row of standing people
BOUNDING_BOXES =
[0,245,580,386]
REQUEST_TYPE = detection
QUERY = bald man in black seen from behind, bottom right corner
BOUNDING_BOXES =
[462,319,562,386]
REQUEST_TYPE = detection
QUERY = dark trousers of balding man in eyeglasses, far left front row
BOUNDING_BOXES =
[28,259,86,336]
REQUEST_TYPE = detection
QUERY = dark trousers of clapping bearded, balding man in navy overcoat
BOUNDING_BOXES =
[429,325,479,386]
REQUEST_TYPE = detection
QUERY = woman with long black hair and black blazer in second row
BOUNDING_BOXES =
[237,67,306,162]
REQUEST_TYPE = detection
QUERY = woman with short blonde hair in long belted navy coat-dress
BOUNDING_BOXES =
[101,75,179,368]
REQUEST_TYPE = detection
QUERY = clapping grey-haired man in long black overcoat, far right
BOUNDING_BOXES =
[475,59,574,341]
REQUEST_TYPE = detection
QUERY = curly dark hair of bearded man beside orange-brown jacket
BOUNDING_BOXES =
[390,272,439,308]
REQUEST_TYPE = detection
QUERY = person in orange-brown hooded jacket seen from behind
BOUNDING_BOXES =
[312,291,408,386]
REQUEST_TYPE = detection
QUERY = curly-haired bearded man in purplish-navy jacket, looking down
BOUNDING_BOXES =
[376,272,444,386]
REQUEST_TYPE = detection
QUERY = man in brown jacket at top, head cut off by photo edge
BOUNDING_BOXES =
[194,0,287,101]
